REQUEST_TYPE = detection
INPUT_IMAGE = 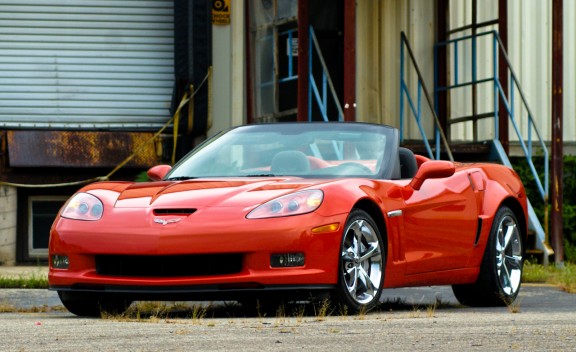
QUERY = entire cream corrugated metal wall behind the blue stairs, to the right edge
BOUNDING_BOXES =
[356,0,576,145]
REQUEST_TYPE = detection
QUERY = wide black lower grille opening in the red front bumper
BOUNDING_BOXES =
[96,254,242,277]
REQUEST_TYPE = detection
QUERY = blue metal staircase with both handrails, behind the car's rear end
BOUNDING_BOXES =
[400,31,554,264]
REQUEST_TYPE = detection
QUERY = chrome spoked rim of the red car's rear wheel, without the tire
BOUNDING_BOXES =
[495,215,523,296]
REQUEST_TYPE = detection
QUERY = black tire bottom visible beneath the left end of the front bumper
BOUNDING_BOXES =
[58,291,132,317]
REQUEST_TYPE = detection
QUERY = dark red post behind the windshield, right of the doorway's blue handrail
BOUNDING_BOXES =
[343,0,356,121]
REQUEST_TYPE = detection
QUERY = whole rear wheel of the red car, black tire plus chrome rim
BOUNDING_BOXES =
[452,206,524,307]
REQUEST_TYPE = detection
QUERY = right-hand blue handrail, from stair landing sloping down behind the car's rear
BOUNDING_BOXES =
[435,31,549,202]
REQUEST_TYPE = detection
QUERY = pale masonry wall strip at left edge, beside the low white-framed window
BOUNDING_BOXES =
[0,186,17,265]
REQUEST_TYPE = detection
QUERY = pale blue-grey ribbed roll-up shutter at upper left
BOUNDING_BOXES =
[0,0,174,129]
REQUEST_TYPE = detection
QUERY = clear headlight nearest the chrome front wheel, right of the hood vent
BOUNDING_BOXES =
[246,190,324,219]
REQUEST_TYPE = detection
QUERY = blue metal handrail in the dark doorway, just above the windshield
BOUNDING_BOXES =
[308,26,344,122]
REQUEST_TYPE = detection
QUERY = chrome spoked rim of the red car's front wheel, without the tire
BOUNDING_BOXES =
[341,218,383,305]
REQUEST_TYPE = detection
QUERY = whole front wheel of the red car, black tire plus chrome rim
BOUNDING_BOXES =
[336,209,386,313]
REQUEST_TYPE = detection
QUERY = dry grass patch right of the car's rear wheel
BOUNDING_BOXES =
[522,262,576,293]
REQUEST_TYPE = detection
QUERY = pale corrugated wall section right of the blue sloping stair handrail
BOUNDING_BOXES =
[508,0,576,144]
